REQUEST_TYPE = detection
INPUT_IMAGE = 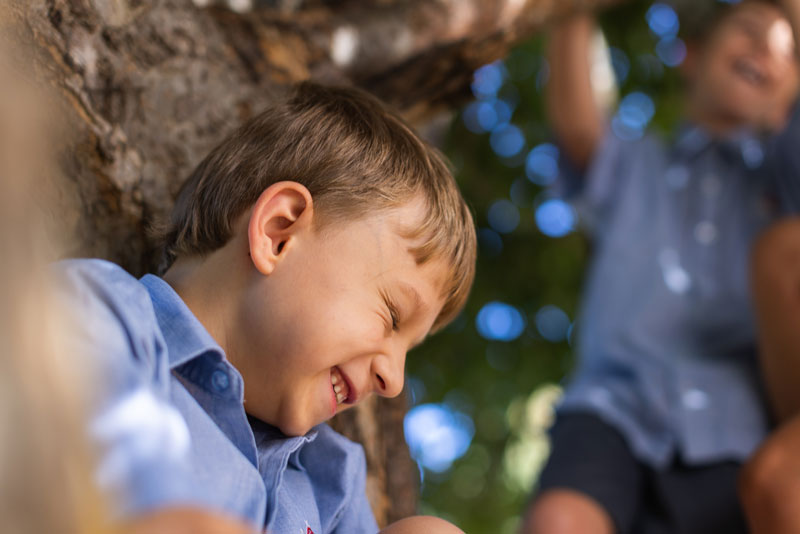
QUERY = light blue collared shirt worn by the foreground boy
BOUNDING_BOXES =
[56,260,378,534]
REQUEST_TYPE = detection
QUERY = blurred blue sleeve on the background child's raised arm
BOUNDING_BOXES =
[551,128,641,237]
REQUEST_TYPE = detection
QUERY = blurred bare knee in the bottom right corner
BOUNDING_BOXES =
[739,417,800,534]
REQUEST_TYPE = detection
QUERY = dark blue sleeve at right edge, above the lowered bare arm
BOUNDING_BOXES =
[767,103,800,214]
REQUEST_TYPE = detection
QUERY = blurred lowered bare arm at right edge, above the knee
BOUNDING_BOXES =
[752,219,800,422]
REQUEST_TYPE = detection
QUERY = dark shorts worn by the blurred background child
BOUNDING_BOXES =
[538,413,747,534]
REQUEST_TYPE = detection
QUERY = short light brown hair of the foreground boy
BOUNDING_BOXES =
[163,82,476,330]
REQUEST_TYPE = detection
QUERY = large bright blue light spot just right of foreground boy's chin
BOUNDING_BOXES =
[403,404,475,473]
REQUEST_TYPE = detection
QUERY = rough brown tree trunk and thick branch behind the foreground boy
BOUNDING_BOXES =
[0,0,614,524]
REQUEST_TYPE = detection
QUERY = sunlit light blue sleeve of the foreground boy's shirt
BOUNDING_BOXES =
[55,260,205,518]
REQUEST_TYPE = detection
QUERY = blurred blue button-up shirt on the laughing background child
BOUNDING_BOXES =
[557,108,800,466]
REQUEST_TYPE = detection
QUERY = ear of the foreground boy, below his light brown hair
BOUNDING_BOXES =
[247,182,314,275]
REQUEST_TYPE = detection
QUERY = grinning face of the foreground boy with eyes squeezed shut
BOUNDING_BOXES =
[236,199,445,435]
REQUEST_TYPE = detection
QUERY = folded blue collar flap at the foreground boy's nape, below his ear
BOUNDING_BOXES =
[139,274,225,369]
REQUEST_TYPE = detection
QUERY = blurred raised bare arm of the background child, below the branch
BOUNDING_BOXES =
[546,13,604,170]
